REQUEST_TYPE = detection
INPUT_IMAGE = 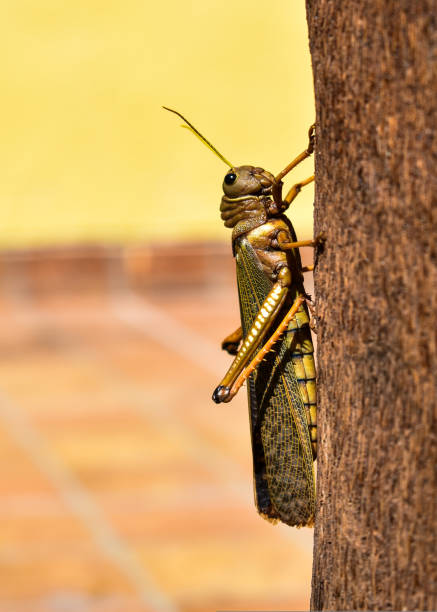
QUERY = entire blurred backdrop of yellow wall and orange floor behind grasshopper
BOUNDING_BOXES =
[0,0,314,612]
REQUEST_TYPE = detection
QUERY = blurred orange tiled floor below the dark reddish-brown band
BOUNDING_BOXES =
[0,249,312,612]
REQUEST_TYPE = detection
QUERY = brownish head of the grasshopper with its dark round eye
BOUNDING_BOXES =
[223,166,275,198]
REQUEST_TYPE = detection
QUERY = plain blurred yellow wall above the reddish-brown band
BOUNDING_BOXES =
[0,0,314,246]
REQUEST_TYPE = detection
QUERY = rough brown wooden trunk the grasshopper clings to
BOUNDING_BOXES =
[307,0,437,610]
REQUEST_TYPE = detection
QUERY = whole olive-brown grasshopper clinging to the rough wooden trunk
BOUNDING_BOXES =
[164,107,322,527]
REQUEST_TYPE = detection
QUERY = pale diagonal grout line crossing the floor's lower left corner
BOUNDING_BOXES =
[0,394,177,612]
